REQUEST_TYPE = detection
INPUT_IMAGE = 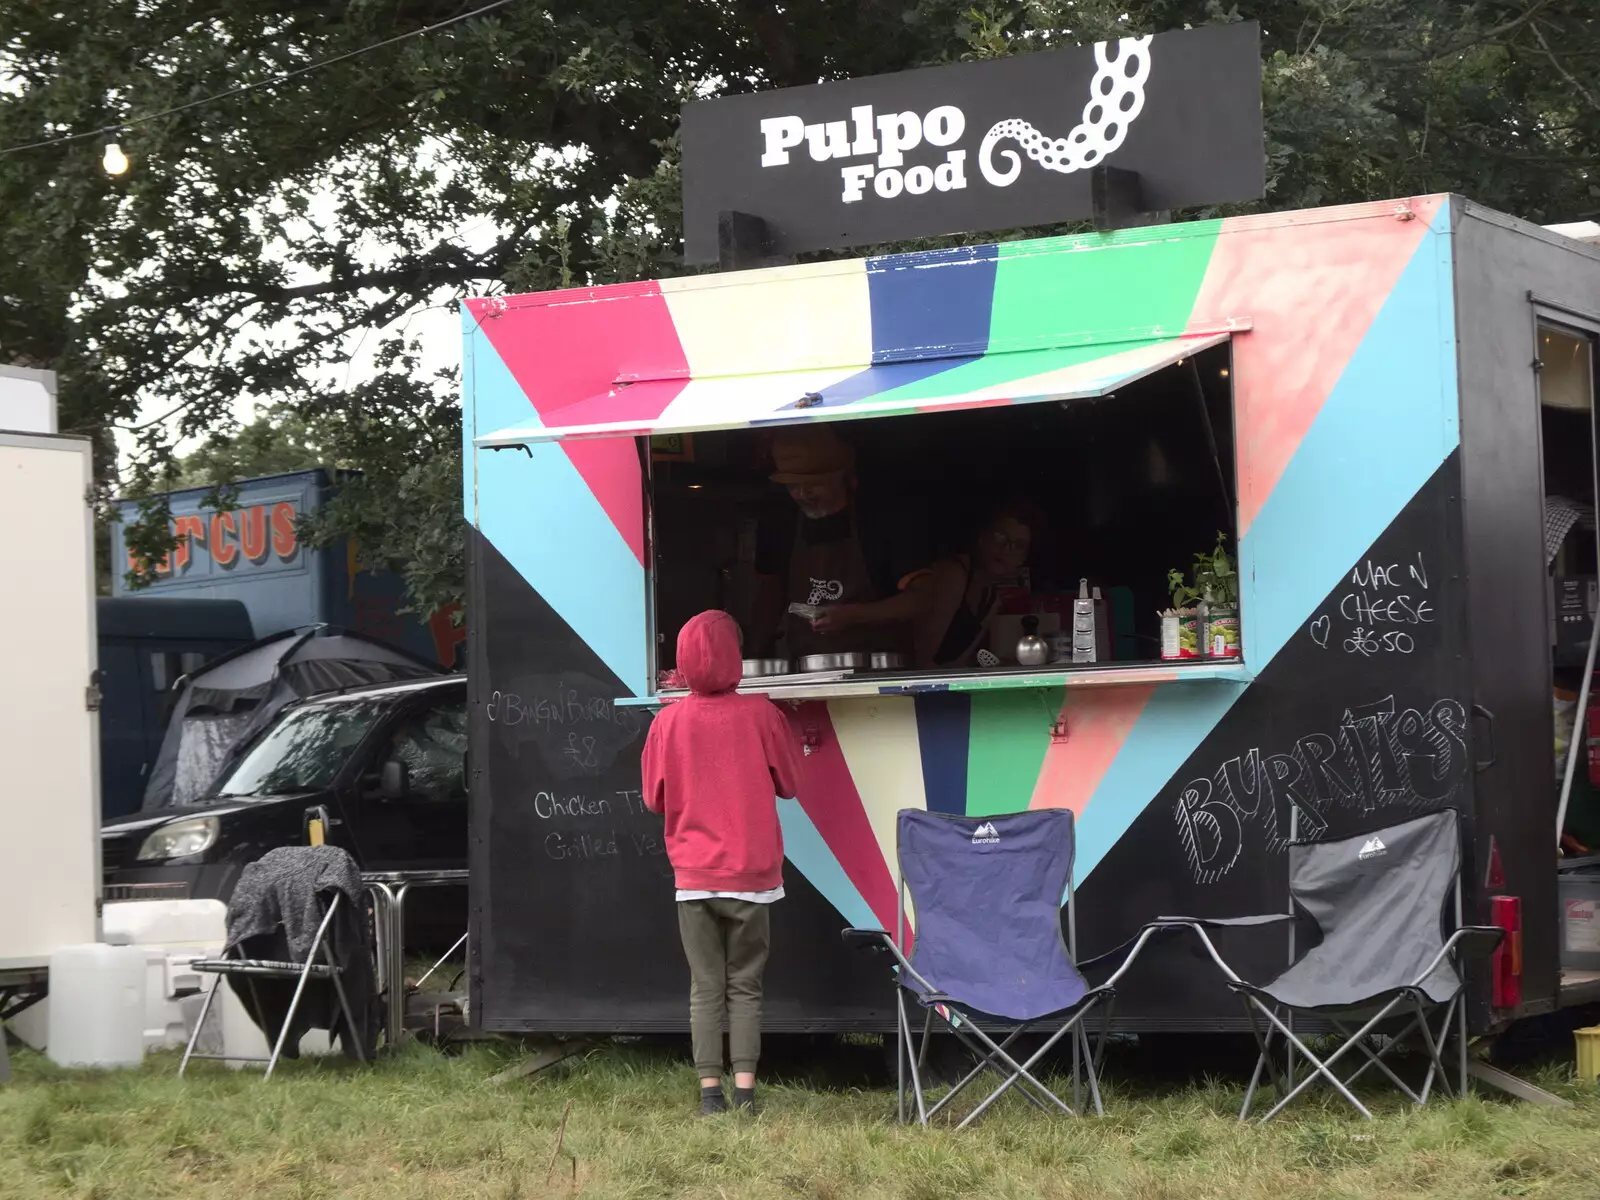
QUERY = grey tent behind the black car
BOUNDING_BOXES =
[142,626,440,811]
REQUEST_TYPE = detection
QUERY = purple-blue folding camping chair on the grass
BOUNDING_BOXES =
[845,808,1157,1128]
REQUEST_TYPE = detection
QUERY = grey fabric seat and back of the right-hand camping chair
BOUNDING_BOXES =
[1256,808,1461,1008]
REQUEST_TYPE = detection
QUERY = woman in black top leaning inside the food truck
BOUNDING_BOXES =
[816,502,1038,669]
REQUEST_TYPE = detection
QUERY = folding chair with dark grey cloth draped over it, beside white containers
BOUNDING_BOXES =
[178,846,370,1078]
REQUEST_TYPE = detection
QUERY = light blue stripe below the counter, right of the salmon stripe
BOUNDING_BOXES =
[1075,684,1248,883]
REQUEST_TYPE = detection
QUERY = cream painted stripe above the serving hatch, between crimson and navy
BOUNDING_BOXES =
[661,259,872,379]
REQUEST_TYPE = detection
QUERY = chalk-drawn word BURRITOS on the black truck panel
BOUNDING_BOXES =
[1173,696,1469,883]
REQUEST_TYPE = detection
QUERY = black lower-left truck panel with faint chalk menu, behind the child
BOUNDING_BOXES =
[469,531,893,1032]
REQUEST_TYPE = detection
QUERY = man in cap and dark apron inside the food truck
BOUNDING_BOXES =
[755,424,925,666]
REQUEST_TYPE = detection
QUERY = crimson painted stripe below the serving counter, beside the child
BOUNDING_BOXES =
[789,701,898,930]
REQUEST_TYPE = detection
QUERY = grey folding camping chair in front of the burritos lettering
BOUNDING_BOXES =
[1147,810,1502,1122]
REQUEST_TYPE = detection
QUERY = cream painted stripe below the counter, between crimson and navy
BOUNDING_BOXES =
[827,696,928,896]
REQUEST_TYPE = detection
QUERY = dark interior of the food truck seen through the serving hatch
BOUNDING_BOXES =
[650,342,1248,691]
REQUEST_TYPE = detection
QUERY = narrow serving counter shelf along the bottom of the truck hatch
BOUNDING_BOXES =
[616,659,1254,709]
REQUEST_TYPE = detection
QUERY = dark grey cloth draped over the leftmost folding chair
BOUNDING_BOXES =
[227,846,365,962]
